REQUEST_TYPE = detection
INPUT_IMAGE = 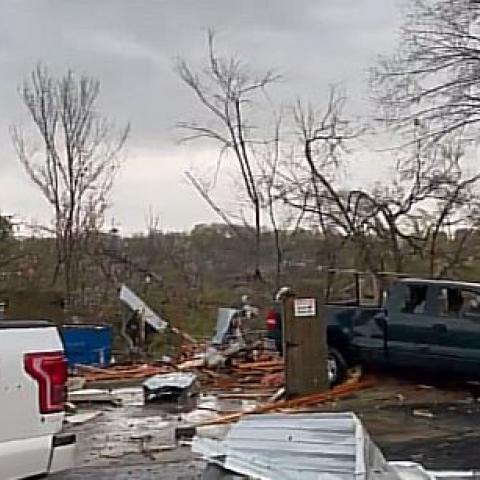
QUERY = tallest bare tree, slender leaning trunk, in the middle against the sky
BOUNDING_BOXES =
[177,31,279,279]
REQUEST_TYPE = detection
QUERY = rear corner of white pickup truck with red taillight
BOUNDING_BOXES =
[0,320,76,480]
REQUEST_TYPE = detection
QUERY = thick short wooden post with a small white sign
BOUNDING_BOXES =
[282,295,329,398]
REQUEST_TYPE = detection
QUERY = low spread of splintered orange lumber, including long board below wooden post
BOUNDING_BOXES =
[69,324,371,422]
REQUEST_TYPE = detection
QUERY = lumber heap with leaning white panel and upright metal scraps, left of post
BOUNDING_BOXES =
[70,294,278,394]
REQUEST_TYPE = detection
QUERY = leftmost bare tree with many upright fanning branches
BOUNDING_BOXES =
[11,65,129,298]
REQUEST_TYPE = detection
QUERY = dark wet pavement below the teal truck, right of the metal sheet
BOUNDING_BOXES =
[336,378,480,470]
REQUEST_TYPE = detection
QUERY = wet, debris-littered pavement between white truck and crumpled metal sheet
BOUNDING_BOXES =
[52,390,204,480]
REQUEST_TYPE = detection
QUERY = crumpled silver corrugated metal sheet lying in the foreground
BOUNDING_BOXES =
[192,413,399,480]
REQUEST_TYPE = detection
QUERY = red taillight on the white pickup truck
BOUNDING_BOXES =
[24,352,68,414]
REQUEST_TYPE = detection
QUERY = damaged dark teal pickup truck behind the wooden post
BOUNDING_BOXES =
[267,278,480,384]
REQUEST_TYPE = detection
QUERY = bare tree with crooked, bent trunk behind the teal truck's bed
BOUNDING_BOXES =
[276,87,366,267]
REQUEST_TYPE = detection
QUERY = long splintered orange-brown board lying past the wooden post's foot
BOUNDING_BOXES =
[197,379,375,426]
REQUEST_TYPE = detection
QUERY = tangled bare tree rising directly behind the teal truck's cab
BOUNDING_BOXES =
[372,122,480,276]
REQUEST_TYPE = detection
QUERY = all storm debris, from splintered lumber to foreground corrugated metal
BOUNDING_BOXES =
[60,289,475,480]
